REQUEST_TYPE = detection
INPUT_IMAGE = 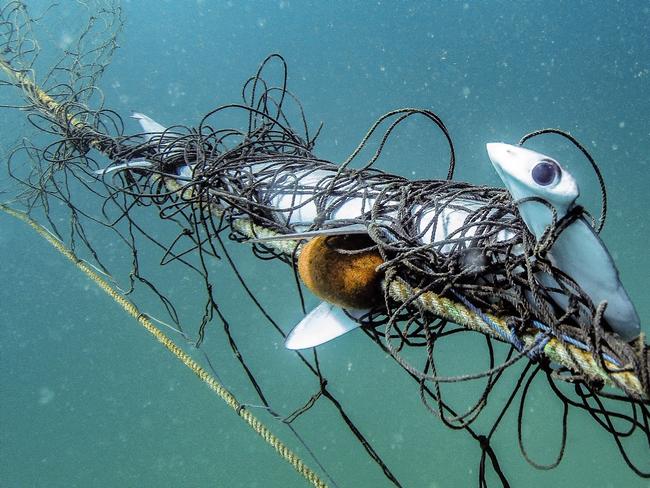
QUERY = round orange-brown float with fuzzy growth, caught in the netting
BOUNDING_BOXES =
[298,234,383,309]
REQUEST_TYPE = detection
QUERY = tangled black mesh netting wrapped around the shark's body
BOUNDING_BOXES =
[2,2,650,486]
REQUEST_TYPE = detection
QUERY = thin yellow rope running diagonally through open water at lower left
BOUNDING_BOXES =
[0,204,327,488]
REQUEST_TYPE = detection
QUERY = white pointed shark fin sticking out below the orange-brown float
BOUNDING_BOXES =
[284,302,367,349]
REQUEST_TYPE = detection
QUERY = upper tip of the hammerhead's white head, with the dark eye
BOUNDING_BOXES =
[486,142,580,239]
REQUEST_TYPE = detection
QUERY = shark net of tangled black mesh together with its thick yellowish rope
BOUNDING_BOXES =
[0,2,650,486]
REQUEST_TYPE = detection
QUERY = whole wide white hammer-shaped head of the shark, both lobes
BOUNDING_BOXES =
[487,143,641,340]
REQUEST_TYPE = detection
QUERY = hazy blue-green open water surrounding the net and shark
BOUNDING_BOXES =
[0,0,650,488]
